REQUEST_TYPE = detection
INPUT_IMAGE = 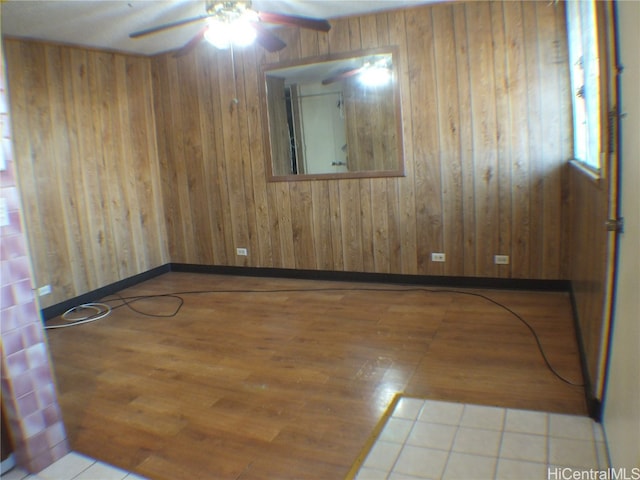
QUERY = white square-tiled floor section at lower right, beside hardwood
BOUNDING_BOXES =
[355,397,609,480]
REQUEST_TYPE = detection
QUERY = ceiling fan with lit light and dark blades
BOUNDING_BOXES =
[129,0,331,56]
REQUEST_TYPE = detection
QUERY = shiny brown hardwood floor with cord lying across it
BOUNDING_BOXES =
[47,272,586,480]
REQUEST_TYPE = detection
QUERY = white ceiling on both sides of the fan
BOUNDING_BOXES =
[0,0,435,55]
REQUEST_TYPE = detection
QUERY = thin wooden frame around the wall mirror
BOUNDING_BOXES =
[259,46,405,182]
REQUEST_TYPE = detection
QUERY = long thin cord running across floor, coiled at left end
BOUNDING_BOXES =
[45,287,584,387]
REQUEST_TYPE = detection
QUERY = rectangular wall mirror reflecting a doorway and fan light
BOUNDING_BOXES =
[262,48,404,181]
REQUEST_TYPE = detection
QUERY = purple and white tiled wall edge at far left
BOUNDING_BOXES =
[0,44,69,472]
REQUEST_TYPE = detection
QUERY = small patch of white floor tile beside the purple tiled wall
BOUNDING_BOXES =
[0,452,145,480]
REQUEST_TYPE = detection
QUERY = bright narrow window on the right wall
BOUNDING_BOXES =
[567,0,601,170]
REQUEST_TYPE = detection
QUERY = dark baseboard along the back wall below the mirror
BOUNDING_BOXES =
[171,263,571,292]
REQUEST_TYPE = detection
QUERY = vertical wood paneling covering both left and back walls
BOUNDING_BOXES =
[6,1,571,304]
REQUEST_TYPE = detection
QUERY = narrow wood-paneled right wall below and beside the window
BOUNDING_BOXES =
[567,1,621,404]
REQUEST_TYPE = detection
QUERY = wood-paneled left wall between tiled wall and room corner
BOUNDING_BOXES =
[4,40,169,307]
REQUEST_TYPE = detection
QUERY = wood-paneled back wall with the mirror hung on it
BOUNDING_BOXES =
[152,1,571,279]
